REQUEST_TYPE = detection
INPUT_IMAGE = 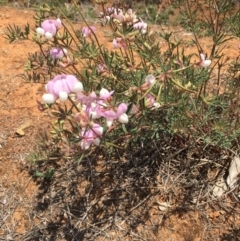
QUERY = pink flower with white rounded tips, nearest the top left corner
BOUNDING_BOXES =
[36,18,62,39]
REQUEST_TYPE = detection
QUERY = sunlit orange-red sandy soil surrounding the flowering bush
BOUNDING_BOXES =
[0,3,239,241]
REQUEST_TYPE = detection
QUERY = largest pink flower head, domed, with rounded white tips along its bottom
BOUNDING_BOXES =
[42,74,83,104]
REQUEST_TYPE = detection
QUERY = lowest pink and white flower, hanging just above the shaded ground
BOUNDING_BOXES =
[80,123,103,150]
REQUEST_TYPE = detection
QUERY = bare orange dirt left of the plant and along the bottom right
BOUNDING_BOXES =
[0,3,240,241]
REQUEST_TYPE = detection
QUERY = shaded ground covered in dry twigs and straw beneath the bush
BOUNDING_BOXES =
[21,133,239,241]
